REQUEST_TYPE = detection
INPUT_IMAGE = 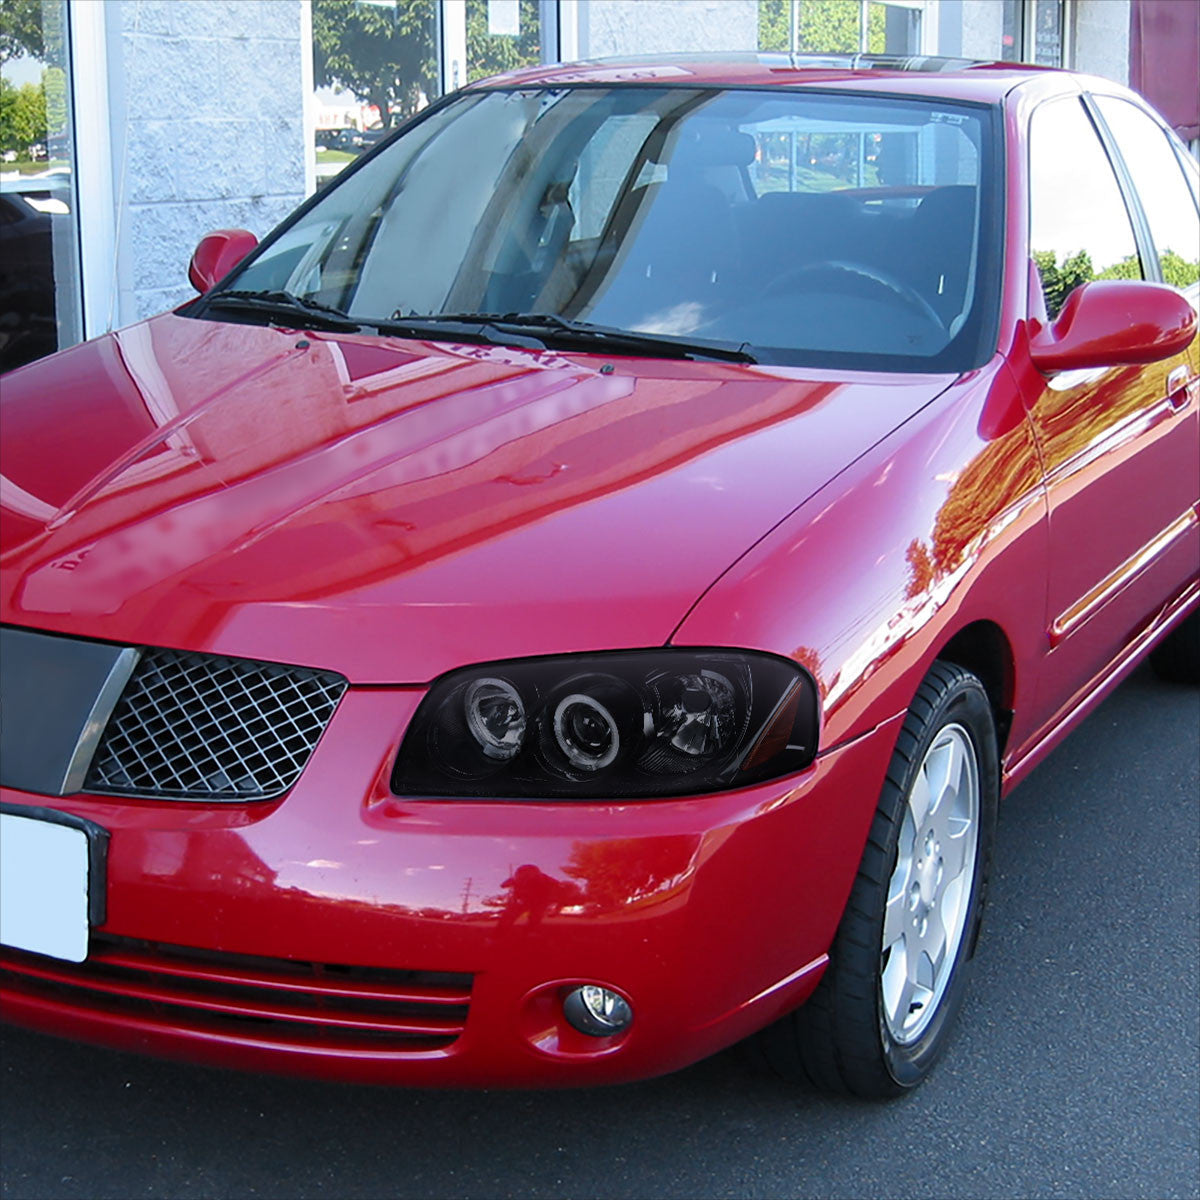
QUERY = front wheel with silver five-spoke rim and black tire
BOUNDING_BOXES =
[760,662,1000,1098]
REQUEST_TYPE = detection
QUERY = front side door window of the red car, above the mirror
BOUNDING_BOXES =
[1030,100,1144,317]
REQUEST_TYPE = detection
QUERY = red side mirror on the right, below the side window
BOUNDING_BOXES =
[1030,280,1196,373]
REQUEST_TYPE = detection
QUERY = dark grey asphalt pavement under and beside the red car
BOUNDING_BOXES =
[0,670,1200,1200]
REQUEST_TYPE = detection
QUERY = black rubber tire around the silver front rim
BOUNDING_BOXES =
[757,661,1000,1099]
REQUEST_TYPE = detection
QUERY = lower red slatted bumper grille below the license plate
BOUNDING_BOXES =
[0,936,473,1051]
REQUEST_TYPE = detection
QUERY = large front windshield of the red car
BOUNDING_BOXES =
[210,86,1000,371]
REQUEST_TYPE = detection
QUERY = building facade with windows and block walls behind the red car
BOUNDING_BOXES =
[0,0,1200,367]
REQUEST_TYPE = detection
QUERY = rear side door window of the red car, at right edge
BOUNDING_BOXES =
[1096,96,1200,288]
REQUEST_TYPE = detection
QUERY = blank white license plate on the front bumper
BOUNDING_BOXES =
[0,812,93,962]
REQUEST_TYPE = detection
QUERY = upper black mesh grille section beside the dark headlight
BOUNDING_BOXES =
[84,649,347,800]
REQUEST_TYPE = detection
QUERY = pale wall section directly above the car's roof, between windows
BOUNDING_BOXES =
[578,0,758,59]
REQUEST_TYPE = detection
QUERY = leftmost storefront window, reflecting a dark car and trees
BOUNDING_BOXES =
[0,0,83,372]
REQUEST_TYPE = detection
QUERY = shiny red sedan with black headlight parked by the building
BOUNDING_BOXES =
[0,55,1200,1096]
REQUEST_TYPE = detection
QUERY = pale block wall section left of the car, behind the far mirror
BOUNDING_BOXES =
[104,0,311,325]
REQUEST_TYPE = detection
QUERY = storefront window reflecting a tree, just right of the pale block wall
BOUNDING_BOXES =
[312,0,442,186]
